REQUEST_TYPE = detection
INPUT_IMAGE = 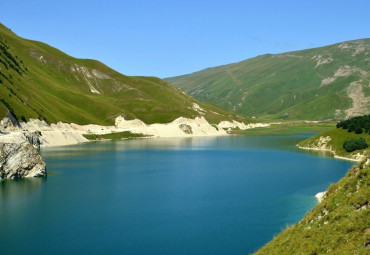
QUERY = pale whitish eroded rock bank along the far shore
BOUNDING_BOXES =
[0,113,268,146]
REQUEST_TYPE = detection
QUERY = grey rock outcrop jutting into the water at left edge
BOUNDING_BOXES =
[0,143,46,180]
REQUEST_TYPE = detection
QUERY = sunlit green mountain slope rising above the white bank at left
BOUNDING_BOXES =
[0,24,246,125]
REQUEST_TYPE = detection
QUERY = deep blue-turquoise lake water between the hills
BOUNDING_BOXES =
[0,135,352,254]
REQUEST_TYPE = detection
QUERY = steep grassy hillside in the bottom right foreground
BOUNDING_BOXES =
[256,160,370,255]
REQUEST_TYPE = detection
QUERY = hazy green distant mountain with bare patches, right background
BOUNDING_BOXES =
[165,39,370,120]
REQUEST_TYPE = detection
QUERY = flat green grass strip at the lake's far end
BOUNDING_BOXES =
[231,122,335,135]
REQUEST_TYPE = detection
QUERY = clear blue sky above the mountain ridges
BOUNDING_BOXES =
[0,0,370,78]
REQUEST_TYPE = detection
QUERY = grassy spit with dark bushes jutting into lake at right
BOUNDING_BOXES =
[299,128,370,158]
